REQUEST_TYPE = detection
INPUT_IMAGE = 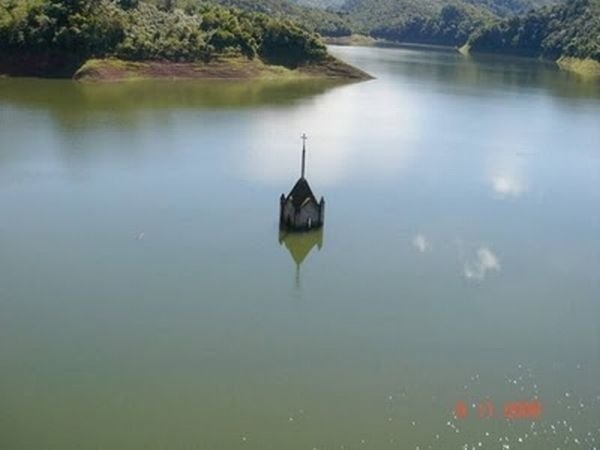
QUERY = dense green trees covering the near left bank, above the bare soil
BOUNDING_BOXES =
[0,0,326,71]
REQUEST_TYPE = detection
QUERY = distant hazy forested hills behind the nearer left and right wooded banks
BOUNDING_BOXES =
[146,0,559,50]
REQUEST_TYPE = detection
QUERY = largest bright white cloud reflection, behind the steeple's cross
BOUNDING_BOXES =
[236,82,425,186]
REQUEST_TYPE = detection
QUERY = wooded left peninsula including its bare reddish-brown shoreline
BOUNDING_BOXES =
[0,0,371,81]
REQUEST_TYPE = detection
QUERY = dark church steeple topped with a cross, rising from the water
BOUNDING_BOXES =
[279,134,325,231]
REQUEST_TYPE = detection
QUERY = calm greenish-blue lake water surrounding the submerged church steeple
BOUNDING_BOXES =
[0,48,600,450]
